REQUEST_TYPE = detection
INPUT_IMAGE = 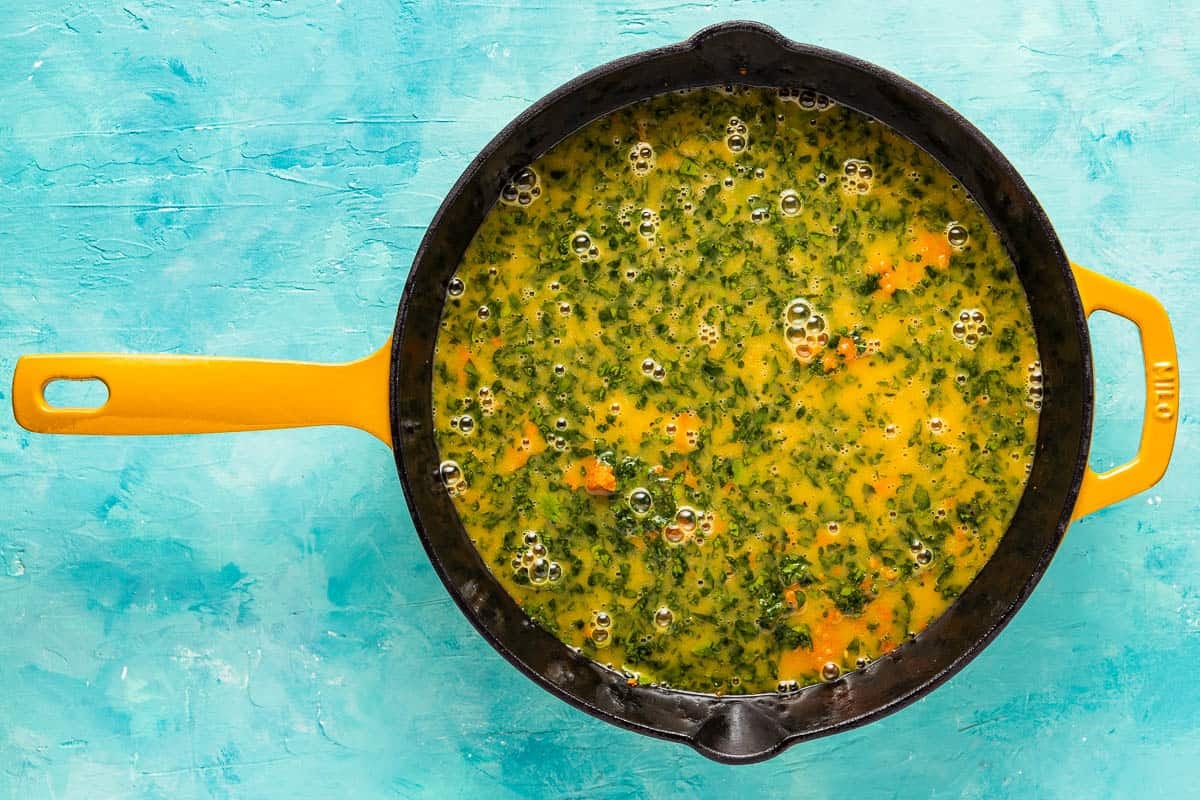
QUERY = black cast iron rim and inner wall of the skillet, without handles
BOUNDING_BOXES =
[391,23,1092,763]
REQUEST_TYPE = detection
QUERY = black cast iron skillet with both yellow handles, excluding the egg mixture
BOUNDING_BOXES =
[13,22,1177,763]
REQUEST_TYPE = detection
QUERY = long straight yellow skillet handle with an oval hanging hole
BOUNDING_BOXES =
[12,342,391,446]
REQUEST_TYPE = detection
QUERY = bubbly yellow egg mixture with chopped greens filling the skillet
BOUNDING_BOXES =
[433,88,1043,693]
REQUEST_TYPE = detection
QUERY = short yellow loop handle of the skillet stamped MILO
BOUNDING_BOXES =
[1072,264,1180,519]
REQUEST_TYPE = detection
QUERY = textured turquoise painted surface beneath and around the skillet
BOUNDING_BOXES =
[0,0,1200,800]
